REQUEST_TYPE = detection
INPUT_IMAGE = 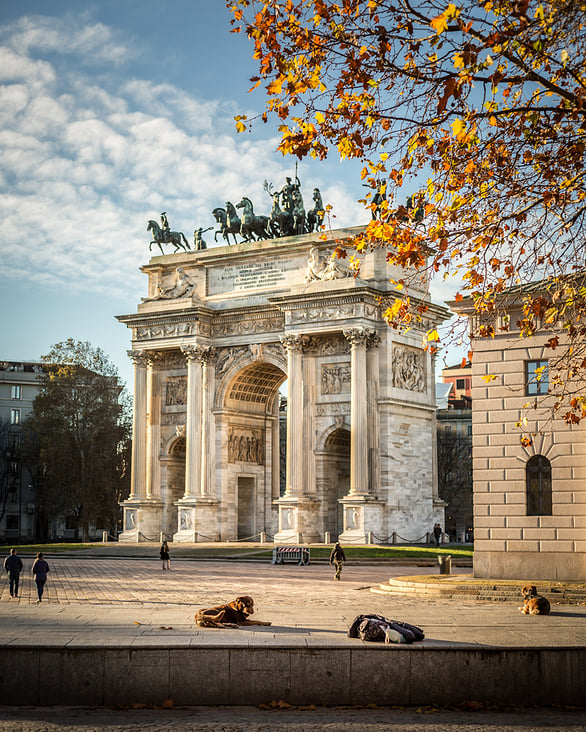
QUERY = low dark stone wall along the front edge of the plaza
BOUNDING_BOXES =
[0,644,586,706]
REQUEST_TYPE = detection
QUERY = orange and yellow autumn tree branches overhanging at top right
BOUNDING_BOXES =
[227,0,586,421]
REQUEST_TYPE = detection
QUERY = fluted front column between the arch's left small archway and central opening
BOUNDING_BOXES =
[181,346,202,498]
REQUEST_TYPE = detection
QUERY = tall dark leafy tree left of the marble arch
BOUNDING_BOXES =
[25,338,131,541]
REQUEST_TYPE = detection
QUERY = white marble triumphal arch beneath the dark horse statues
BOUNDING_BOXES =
[119,228,448,543]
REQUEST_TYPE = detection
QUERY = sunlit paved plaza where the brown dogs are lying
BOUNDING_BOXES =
[0,546,586,648]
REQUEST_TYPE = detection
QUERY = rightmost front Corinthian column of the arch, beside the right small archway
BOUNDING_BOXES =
[344,328,374,496]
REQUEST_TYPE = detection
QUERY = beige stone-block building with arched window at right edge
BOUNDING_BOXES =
[450,287,586,580]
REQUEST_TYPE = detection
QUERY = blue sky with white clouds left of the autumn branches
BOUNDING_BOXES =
[0,0,459,389]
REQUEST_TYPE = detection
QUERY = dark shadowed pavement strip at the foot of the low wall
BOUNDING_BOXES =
[0,707,586,732]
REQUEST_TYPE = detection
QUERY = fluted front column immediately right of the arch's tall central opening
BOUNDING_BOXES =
[281,333,304,496]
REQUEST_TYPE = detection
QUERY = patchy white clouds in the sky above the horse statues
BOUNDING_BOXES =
[0,17,374,308]
